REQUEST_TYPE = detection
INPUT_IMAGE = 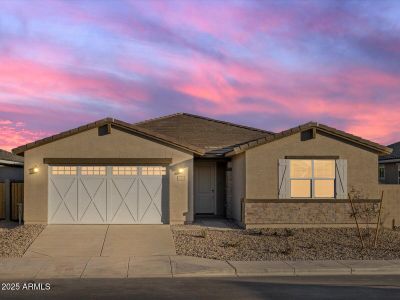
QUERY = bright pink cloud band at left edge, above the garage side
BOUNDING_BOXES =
[0,56,147,105]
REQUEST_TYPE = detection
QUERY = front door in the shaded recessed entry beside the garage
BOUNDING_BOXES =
[194,163,216,214]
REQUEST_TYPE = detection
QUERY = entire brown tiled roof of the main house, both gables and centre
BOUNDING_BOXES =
[11,113,392,159]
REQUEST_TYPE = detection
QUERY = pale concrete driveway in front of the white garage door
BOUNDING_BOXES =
[24,225,176,257]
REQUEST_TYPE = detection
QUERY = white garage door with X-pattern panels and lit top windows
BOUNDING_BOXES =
[48,166,167,224]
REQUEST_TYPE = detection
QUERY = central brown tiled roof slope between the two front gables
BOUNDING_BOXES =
[134,113,273,156]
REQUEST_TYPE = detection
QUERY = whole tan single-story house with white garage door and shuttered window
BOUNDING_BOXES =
[13,113,391,227]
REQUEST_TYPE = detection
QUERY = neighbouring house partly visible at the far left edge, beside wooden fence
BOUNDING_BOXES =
[0,149,24,220]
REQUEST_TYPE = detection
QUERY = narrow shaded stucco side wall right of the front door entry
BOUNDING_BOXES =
[231,153,246,222]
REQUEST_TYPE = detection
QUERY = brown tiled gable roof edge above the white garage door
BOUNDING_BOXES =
[12,118,204,155]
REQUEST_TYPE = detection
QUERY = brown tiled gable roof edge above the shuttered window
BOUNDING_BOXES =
[226,122,392,156]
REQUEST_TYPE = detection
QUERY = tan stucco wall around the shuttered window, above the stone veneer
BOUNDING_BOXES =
[246,132,379,199]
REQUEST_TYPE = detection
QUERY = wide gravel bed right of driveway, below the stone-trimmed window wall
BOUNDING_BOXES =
[173,227,400,261]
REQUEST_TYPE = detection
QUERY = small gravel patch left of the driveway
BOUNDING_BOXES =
[0,222,46,257]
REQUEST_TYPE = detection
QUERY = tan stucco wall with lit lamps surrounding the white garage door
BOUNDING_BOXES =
[24,128,193,223]
